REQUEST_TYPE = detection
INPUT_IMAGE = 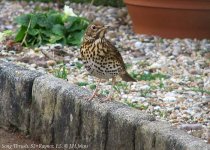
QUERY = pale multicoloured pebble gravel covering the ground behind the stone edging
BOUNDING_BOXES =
[0,1,210,143]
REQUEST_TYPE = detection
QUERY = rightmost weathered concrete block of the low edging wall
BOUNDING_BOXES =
[135,121,208,150]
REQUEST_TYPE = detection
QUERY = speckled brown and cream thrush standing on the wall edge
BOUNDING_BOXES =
[80,21,136,100]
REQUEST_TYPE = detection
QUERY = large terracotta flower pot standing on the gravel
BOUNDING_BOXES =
[124,0,210,39]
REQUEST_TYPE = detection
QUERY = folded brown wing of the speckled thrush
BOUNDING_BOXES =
[106,40,125,69]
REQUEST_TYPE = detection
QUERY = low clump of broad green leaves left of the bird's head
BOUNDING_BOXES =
[15,11,89,46]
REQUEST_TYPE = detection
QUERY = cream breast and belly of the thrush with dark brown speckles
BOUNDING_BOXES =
[80,39,122,79]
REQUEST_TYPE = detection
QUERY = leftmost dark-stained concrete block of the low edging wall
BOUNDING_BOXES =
[0,63,42,133]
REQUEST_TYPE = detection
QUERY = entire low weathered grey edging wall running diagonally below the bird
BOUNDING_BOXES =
[0,63,210,150]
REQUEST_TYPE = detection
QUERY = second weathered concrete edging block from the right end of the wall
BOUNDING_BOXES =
[106,106,155,150]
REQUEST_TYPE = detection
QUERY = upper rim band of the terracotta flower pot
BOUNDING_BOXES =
[124,0,210,10]
